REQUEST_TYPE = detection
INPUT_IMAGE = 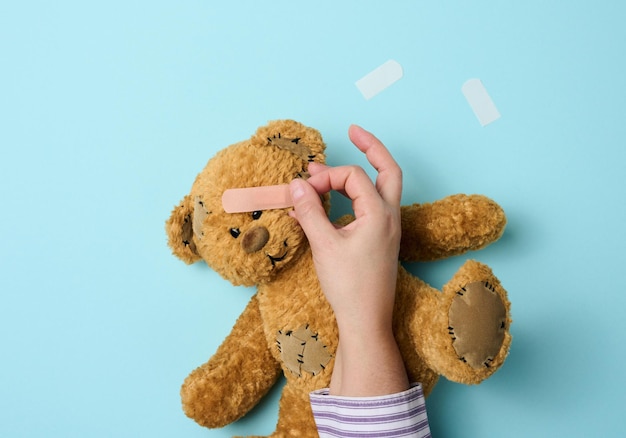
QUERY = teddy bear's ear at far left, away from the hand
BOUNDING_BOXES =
[165,195,200,264]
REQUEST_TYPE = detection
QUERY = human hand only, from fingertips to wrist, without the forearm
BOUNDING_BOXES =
[291,126,402,329]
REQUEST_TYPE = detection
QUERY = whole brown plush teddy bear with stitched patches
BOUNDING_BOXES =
[166,120,511,437]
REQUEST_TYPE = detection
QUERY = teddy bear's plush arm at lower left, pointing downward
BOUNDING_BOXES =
[181,296,281,428]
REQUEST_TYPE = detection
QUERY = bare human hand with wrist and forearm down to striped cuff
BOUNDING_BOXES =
[290,126,408,395]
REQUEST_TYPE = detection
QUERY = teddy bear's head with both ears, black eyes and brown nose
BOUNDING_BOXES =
[166,120,329,286]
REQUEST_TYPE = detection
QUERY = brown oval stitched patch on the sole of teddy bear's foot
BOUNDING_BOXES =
[448,282,506,369]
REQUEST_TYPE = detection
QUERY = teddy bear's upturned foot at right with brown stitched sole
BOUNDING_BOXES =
[420,260,511,384]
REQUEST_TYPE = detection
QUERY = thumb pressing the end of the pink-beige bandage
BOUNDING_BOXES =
[289,178,335,246]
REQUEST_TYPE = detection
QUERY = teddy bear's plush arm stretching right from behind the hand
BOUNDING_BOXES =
[400,194,506,261]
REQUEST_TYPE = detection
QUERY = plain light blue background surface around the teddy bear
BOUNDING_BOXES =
[0,0,626,437]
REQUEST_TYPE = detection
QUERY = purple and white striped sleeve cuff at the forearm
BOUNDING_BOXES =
[310,384,430,438]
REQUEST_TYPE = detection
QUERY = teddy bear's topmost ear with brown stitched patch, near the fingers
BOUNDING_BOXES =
[250,120,326,163]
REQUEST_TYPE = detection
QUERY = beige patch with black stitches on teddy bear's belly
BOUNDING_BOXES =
[276,324,331,377]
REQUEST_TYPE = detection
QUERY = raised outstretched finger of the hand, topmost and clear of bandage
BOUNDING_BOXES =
[348,125,402,207]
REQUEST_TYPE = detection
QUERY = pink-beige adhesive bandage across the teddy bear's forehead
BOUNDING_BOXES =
[222,184,293,213]
